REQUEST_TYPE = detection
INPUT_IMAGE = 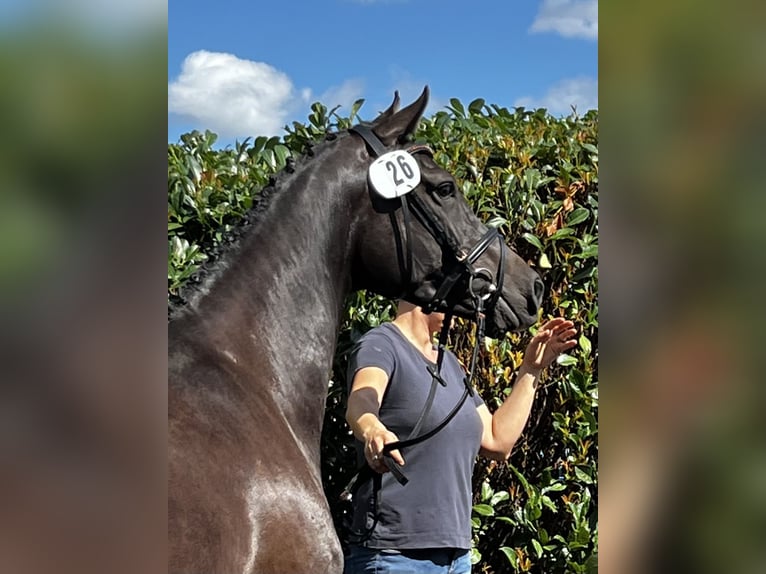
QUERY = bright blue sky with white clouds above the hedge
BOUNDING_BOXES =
[168,0,598,146]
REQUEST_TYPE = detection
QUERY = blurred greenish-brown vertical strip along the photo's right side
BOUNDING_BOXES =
[599,1,766,574]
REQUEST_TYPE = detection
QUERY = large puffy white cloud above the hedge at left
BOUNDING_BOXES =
[168,50,300,137]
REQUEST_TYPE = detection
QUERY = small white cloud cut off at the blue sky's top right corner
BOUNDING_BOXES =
[530,0,598,40]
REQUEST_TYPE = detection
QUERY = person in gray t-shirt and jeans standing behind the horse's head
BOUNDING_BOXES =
[345,301,576,574]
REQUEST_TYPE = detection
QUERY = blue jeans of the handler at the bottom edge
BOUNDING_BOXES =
[343,546,471,574]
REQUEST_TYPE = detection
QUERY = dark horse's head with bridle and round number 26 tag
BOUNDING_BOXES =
[352,87,543,336]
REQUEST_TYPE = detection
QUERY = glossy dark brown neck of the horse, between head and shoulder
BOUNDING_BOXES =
[199,153,354,450]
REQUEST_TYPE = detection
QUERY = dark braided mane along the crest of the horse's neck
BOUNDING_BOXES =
[168,132,350,319]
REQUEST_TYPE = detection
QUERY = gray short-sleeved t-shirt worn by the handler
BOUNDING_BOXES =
[348,323,483,550]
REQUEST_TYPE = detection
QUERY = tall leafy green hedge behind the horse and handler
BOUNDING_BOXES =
[168,99,598,574]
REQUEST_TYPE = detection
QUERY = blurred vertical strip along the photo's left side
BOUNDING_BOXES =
[0,0,167,574]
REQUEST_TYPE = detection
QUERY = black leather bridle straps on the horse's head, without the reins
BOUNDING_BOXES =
[349,125,505,320]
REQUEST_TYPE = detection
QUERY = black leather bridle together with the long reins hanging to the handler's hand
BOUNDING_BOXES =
[341,125,505,539]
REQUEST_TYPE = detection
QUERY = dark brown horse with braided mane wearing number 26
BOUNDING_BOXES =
[168,86,543,574]
